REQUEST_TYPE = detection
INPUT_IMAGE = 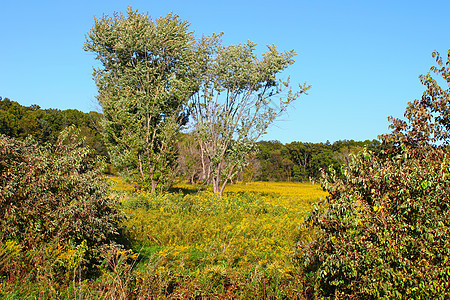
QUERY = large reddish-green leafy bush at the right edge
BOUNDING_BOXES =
[298,50,450,299]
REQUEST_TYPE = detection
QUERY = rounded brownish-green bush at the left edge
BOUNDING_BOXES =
[0,127,121,282]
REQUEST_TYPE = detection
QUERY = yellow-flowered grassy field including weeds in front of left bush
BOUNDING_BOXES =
[0,177,326,300]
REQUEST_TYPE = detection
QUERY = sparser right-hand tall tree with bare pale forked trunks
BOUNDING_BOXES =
[190,35,309,196]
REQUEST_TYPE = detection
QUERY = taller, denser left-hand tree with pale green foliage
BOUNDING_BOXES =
[84,8,197,191]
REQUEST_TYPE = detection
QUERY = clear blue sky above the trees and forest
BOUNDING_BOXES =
[0,0,450,143]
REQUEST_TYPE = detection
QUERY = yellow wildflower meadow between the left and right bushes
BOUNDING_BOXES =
[111,177,326,299]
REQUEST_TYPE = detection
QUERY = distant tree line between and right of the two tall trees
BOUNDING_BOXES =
[178,134,381,184]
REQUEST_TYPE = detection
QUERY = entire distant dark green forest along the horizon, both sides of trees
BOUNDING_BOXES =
[0,97,380,183]
